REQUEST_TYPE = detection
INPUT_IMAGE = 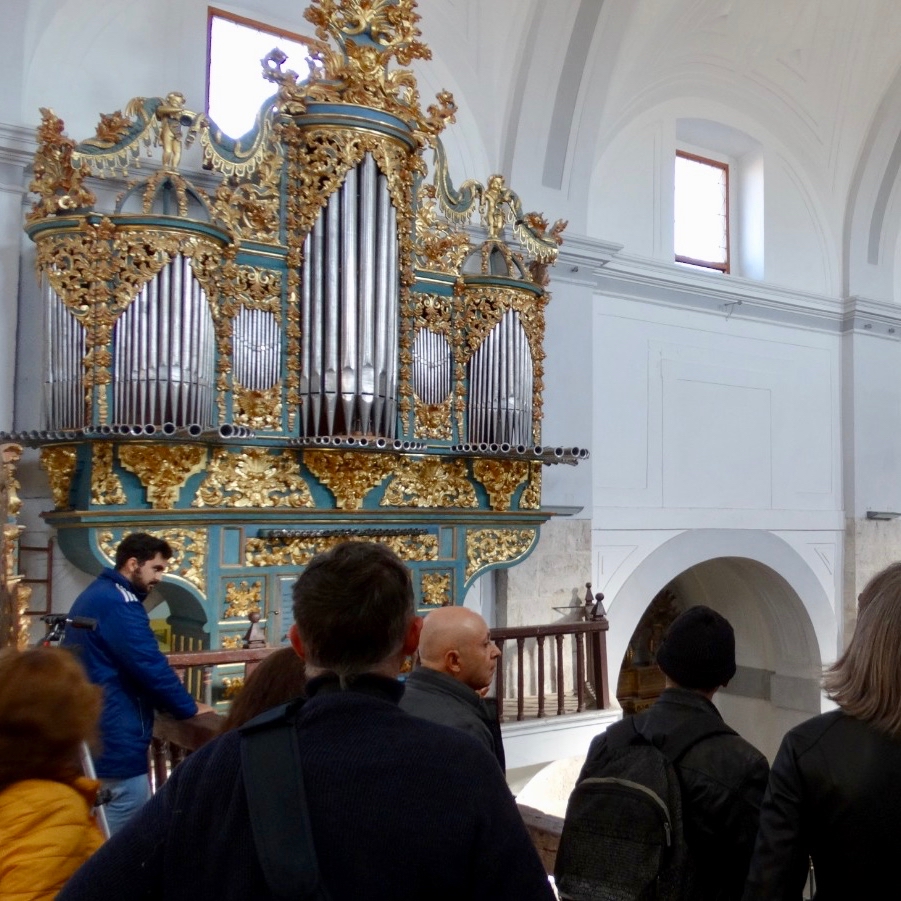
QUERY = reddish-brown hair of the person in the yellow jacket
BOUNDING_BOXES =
[0,648,103,791]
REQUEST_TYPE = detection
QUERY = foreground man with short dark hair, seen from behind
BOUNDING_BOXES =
[59,542,553,901]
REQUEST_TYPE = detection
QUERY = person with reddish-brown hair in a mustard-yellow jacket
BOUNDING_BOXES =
[0,648,103,901]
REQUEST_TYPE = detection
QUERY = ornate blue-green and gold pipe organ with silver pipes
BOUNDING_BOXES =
[7,0,587,696]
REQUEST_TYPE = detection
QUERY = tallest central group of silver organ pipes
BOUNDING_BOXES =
[300,153,399,437]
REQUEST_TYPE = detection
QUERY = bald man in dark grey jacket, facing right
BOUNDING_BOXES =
[400,607,504,770]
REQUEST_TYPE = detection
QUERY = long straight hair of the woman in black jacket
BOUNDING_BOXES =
[823,563,901,738]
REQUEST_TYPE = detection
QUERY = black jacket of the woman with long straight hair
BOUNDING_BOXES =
[744,710,901,901]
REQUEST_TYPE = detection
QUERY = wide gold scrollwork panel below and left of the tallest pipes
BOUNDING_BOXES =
[192,447,314,507]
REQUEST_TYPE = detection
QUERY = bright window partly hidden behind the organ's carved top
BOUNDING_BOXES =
[206,6,319,138]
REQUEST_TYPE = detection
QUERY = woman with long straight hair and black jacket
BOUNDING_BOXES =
[744,563,901,901]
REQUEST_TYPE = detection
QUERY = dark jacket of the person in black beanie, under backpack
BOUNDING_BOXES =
[579,688,769,901]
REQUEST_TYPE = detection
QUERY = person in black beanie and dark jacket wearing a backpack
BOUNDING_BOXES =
[579,605,769,901]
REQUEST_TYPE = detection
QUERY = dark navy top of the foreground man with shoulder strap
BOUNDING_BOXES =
[59,676,553,901]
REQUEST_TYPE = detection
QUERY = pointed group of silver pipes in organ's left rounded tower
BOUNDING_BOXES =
[113,256,215,426]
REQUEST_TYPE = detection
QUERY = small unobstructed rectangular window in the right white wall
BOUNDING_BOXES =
[674,150,729,273]
